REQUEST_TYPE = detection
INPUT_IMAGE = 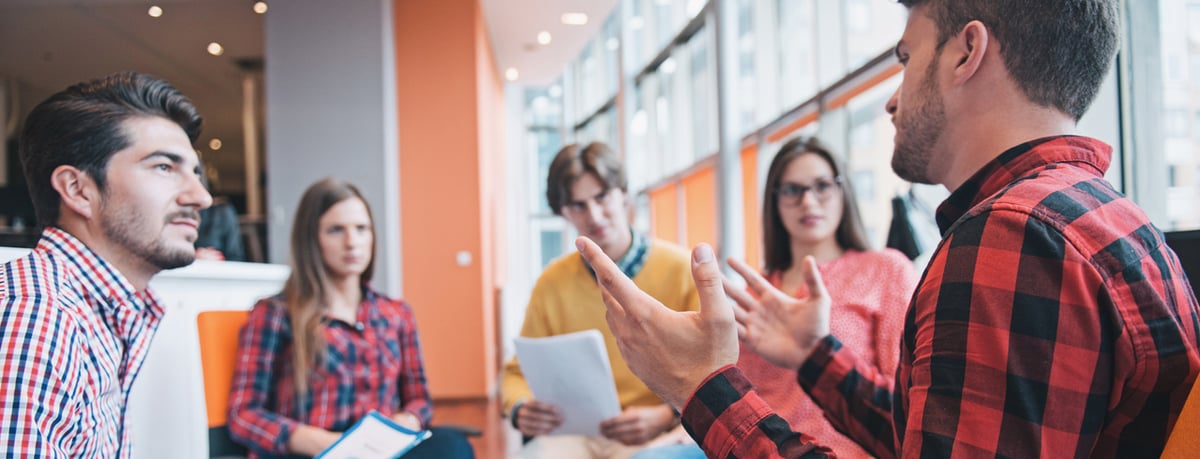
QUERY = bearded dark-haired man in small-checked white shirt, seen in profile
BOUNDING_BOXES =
[0,73,212,458]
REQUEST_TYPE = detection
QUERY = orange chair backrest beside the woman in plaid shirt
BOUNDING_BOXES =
[196,311,250,458]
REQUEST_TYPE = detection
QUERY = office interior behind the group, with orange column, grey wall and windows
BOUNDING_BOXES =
[0,0,1200,457]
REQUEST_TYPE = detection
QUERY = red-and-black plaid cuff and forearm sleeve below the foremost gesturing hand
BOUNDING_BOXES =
[682,365,833,458]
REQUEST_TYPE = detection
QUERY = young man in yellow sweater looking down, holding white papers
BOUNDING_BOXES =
[502,143,703,459]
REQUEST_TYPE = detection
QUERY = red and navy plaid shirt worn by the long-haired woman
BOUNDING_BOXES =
[229,287,433,458]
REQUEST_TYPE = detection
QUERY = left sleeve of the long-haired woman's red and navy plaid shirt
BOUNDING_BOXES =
[229,299,300,454]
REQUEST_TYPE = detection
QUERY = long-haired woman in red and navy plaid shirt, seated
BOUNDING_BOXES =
[229,179,474,458]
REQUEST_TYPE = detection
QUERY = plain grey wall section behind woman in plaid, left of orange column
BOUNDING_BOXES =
[264,0,401,296]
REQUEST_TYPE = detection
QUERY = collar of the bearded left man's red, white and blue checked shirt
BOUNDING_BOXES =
[34,227,162,315]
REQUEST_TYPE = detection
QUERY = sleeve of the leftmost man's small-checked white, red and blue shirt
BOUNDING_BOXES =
[0,296,86,458]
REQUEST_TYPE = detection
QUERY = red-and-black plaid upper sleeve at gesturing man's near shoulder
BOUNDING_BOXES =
[898,210,1115,458]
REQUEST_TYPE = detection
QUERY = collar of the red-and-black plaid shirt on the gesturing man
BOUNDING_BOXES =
[937,136,1112,236]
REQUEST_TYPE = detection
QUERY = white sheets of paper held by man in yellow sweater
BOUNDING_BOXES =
[515,329,620,436]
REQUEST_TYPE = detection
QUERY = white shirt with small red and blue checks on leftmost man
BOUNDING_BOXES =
[0,228,163,458]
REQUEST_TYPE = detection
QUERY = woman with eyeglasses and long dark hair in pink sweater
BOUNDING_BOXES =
[738,138,917,458]
